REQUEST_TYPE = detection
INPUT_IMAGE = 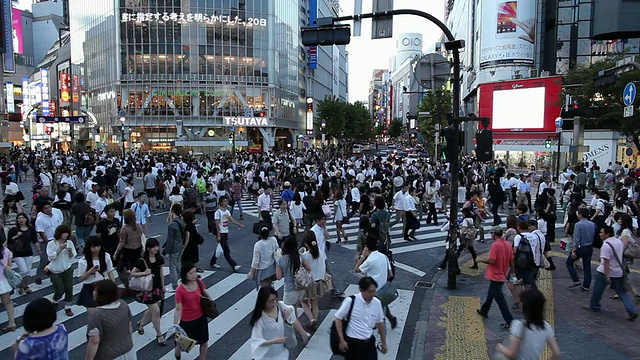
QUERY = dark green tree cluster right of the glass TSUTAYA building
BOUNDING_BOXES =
[315,96,373,139]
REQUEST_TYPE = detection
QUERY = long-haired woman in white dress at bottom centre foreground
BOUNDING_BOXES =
[249,286,300,360]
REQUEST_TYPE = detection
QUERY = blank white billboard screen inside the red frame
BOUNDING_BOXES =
[491,87,545,129]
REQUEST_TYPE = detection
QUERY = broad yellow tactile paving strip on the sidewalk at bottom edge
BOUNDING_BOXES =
[436,296,489,360]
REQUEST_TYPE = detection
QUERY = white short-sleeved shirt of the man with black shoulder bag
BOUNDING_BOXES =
[336,294,384,340]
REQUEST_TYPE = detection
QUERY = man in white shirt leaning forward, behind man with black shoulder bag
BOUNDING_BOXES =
[354,236,398,329]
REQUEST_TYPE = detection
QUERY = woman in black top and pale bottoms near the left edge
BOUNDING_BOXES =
[7,213,38,295]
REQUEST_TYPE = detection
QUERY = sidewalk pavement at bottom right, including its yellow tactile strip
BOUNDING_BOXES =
[410,242,640,360]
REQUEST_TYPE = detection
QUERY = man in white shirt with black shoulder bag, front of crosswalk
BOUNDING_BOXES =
[335,277,387,360]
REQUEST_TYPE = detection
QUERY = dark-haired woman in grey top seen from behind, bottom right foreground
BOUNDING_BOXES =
[496,288,560,359]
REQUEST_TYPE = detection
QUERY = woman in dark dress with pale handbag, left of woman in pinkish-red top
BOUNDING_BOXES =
[131,238,167,346]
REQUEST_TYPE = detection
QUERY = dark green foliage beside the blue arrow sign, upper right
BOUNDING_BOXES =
[563,56,640,148]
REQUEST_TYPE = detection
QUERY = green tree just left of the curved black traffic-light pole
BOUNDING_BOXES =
[418,89,453,148]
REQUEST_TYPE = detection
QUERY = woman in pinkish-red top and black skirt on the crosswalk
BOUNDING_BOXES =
[173,263,209,360]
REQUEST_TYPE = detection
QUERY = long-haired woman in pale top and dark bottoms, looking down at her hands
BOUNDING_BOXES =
[76,235,115,310]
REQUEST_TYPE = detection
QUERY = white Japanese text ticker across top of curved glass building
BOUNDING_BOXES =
[120,12,267,27]
